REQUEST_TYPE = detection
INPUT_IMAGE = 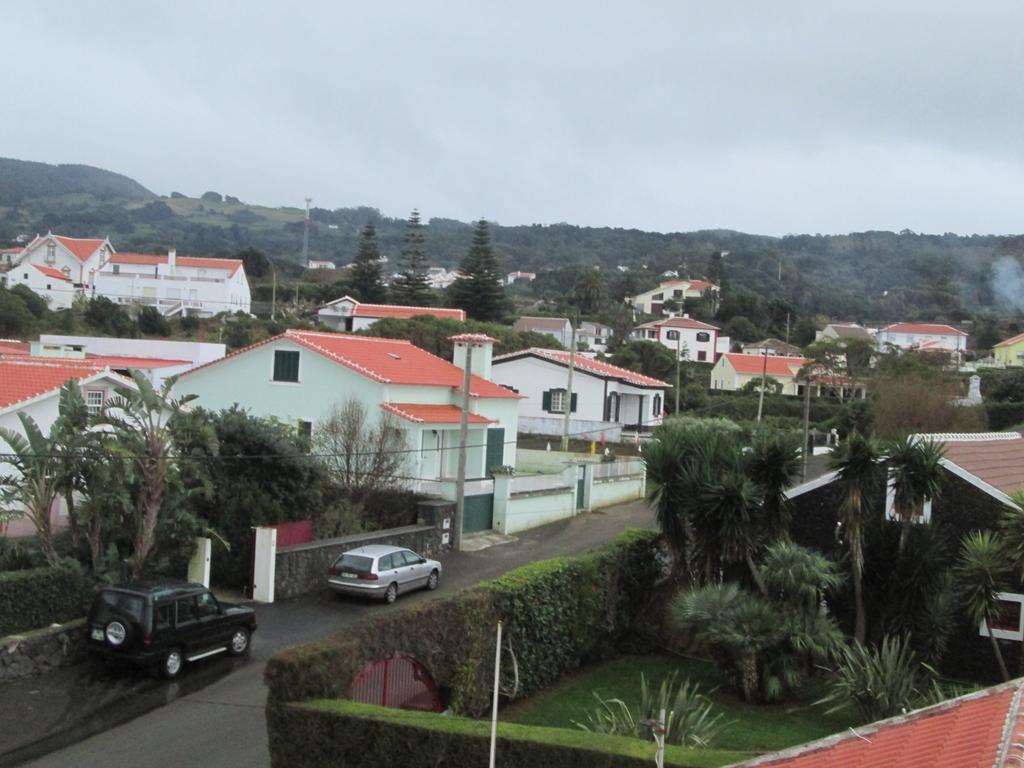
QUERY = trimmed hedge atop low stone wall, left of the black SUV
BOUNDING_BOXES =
[0,567,92,637]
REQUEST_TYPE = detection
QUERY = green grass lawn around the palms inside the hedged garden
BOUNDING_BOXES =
[503,655,859,753]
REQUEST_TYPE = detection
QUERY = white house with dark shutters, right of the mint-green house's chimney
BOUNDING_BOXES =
[494,347,670,440]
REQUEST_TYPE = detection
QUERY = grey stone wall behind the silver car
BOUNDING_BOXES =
[273,501,455,600]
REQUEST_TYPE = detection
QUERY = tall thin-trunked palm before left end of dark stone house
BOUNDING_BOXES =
[830,432,882,644]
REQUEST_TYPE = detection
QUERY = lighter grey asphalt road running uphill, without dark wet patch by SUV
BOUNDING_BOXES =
[22,502,654,768]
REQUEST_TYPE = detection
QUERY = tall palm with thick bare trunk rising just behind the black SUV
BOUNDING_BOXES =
[104,371,196,578]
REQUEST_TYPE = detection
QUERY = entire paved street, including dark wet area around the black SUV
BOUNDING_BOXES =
[8,502,655,768]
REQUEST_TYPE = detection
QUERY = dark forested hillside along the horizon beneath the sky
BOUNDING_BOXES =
[0,160,1024,325]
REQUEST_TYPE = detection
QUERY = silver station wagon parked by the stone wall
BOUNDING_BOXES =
[327,544,441,603]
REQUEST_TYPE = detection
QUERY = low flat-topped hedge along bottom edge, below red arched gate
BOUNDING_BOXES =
[270,700,749,768]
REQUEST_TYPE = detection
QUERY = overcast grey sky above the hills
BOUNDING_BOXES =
[8,0,1024,234]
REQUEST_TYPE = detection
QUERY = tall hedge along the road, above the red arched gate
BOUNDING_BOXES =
[266,531,657,720]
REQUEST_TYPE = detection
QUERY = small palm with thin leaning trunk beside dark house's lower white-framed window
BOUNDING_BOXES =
[955,530,1013,680]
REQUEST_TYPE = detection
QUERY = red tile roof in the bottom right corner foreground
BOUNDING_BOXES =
[734,680,1022,768]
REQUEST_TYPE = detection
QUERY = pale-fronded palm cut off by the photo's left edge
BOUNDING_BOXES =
[0,413,60,567]
